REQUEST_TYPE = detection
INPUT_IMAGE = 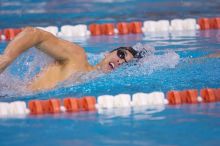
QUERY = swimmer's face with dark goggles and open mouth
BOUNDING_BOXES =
[100,49,134,72]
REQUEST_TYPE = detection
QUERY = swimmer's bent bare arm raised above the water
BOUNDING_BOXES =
[0,27,84,73]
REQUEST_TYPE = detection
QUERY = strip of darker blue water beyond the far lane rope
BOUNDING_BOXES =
[0,0,220,28]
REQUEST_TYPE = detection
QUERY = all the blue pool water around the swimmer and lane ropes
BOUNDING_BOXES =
[0,0,220,146]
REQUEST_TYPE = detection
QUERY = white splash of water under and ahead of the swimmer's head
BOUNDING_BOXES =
[112,43,180,76]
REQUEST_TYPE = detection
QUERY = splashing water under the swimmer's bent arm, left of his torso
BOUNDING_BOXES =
[0,48,54,97]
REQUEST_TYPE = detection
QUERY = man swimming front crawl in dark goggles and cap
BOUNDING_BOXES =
[0,27,138,91]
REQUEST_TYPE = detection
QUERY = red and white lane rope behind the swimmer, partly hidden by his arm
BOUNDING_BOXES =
[0,17,220,41]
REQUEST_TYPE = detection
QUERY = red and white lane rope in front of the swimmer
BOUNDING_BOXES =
[0,88,220,118]
